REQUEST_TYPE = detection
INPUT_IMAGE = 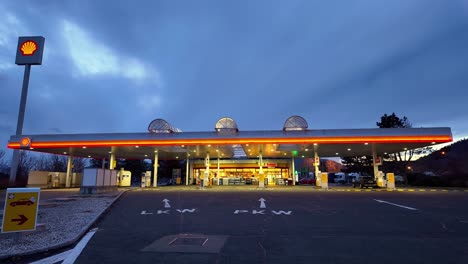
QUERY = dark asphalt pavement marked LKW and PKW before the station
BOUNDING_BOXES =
[76,188,468,264]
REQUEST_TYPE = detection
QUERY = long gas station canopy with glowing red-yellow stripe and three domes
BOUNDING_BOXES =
[8,116,452,159]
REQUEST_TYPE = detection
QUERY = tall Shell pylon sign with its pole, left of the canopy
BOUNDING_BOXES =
[10,36,45,185]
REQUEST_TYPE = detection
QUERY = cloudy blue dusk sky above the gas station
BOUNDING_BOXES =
[0,0,468,153]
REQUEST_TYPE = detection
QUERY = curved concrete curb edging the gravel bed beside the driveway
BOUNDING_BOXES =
[0,189,129,260]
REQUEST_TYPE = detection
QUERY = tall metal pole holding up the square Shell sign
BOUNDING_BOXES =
[10,64,31,185]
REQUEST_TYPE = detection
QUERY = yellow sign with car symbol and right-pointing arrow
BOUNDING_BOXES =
[2,188,40,233]
